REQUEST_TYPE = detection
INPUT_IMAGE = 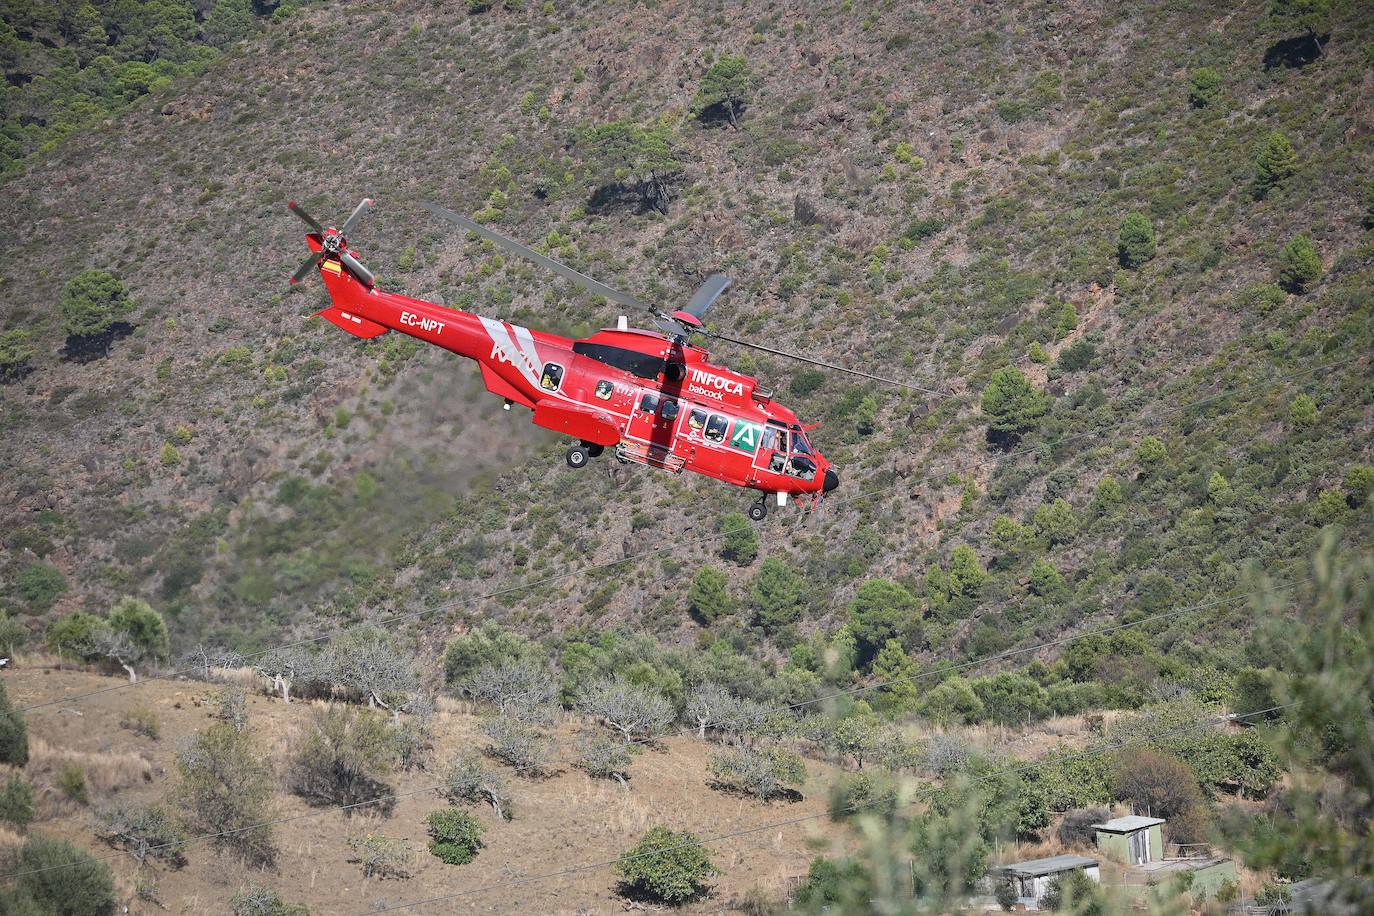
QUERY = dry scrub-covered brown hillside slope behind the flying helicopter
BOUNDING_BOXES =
[0,3,1370,667]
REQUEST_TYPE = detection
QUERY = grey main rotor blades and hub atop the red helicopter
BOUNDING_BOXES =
[420,202,947,397]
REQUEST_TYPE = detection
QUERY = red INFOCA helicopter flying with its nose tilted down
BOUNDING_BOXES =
[289,201,915,522]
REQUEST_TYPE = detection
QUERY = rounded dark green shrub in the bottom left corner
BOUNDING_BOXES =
[10,834,118,916]
